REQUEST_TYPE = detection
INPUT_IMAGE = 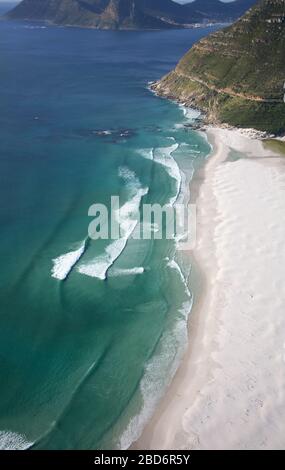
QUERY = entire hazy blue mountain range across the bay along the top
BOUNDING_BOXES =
[6,0,255,29]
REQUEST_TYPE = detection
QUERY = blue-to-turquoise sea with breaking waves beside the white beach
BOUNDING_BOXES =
[0,11,213,449]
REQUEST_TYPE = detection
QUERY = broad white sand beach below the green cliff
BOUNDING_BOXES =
[134,129,285,449]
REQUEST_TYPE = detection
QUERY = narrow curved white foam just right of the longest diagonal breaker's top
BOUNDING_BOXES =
[155,138,182,205]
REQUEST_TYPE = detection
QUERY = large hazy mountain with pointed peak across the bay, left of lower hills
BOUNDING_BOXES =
[7,0,197,29]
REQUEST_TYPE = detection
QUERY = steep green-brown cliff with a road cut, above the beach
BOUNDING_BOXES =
[154,0,285,133]
